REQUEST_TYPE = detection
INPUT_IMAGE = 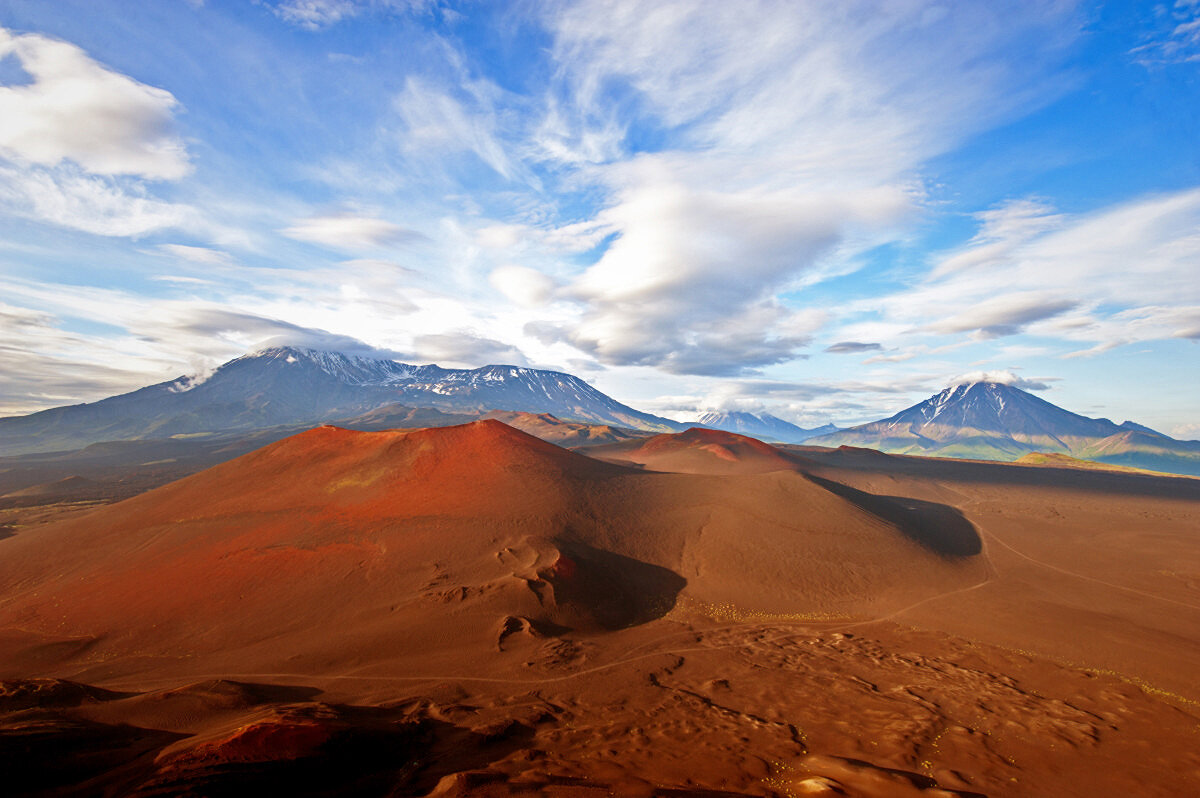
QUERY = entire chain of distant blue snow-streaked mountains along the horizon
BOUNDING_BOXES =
[0,347,1200,475]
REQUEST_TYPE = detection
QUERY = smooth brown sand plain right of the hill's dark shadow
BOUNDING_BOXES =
[805,450,1200,701]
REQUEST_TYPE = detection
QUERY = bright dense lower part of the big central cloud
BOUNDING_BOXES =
[552,178,892,374]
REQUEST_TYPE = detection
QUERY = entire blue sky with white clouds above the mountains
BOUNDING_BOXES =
[0,0,1200,438]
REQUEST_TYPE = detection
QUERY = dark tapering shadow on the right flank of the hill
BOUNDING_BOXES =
[809,474,983,557]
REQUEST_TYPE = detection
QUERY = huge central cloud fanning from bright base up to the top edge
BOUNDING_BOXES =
[520,0,1078,373]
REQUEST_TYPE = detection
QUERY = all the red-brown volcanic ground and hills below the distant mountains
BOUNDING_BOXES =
[0,420,1200,797]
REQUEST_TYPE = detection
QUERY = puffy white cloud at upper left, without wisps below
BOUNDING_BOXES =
[0,29,191,180]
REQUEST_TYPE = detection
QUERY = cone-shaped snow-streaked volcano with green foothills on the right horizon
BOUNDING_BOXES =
[806,383,1200,475]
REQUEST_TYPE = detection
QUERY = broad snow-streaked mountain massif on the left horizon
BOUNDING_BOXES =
[0,347,684,455]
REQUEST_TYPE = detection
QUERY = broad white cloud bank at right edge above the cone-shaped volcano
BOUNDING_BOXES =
[859,188,1200,356]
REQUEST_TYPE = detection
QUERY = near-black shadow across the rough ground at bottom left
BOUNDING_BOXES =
[0,683,535,798]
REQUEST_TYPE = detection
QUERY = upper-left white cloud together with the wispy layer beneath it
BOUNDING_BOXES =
[0,28,199,238]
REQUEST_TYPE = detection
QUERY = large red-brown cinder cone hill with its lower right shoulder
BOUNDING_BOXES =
[0,421,983,680]
